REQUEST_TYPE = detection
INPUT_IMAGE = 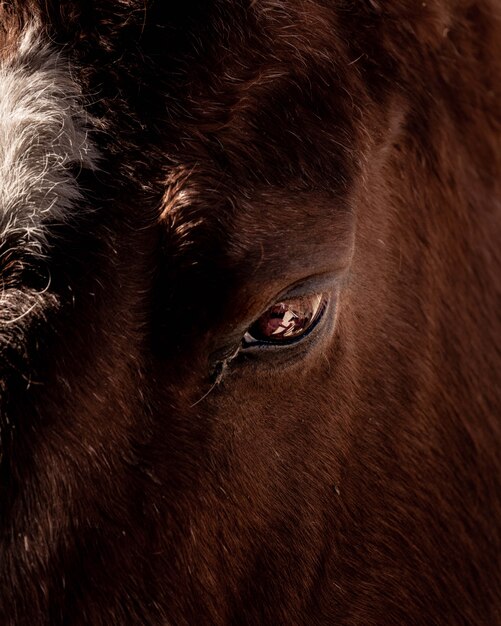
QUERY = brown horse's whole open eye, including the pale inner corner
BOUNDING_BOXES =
[243,294,327,347]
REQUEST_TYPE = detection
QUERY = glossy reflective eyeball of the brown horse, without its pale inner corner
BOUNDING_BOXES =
[249,295,322,341]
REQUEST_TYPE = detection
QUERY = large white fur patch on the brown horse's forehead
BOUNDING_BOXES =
[0,25,97,256]
